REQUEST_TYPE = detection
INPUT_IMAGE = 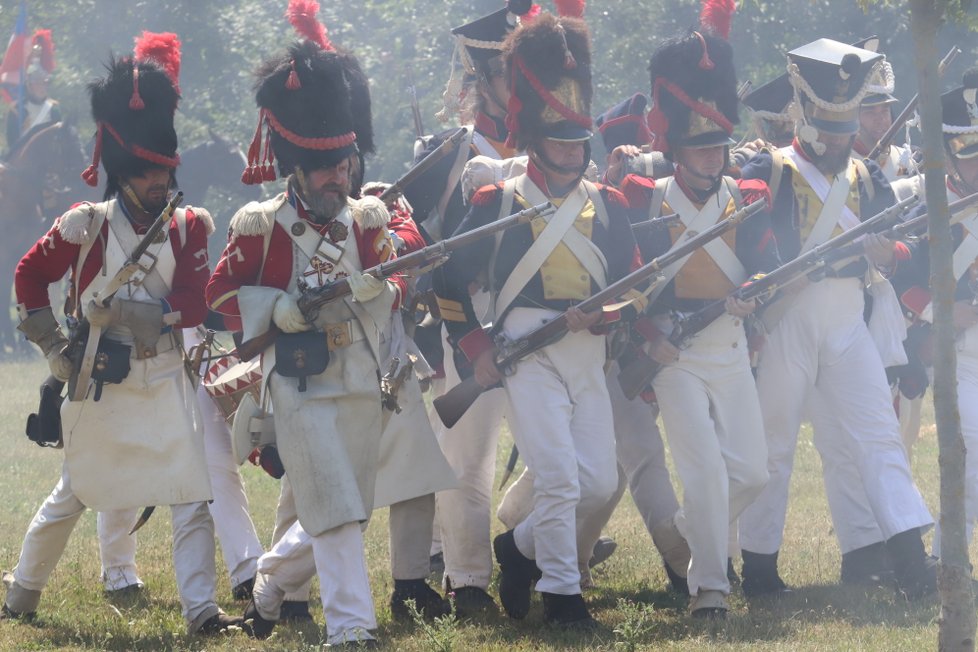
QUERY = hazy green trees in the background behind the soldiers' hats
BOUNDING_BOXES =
[0,0,978,188]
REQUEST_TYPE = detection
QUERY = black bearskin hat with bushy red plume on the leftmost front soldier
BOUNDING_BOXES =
[82,32,180,195]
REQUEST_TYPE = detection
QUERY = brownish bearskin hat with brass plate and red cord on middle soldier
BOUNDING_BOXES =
[505,13,592,149]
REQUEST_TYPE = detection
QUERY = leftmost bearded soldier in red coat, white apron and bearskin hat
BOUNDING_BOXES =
[3,34,240,632]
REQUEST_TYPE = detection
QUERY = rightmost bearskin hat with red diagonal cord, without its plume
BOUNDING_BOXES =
[648,31,739,157]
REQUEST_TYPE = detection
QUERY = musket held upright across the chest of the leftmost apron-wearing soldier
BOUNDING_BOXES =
[65,191,183,401]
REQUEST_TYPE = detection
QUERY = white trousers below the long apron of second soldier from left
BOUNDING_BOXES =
[254,522,377,645]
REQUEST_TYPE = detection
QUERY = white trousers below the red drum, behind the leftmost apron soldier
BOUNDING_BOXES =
[97,385,262,591]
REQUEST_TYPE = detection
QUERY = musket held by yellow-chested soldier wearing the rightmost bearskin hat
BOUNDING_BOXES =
[618,195,926,400]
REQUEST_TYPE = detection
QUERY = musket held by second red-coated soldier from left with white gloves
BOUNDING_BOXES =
[235,202,556,362]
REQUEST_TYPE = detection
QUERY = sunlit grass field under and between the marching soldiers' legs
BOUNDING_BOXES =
[0,361,960,651]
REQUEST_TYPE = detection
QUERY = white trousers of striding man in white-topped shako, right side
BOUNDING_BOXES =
[740,278,933,554]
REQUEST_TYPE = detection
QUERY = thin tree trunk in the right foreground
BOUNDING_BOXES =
[910,0,978,652]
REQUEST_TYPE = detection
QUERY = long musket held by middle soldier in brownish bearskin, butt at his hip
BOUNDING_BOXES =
[434,201,766,428]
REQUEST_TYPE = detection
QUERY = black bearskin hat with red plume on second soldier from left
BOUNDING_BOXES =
[242,0,374,183]
